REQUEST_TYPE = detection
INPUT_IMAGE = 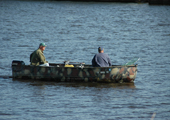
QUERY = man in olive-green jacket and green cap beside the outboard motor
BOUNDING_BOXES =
[30,43,49,66]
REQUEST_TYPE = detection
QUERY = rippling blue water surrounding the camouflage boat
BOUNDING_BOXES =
[0,1,170,120]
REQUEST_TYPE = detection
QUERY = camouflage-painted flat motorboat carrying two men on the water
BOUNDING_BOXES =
[12,60,137,83]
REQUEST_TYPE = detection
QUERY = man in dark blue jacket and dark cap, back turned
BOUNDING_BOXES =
[92,47,112,67]
